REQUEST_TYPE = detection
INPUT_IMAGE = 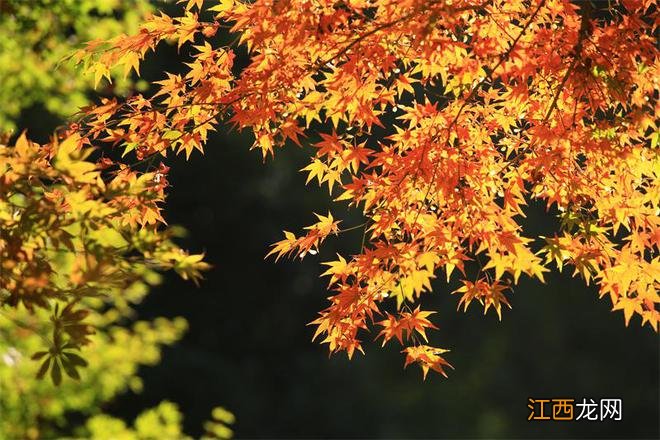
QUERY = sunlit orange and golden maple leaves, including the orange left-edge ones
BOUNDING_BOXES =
[0,0,660,376]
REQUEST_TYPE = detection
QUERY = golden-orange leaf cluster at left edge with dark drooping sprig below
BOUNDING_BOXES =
[0,129,207,376]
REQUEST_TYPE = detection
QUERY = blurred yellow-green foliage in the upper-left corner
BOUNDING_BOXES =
[0,0,153,131]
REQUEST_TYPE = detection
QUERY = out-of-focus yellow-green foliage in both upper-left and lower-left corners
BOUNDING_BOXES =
[0,0,233,439]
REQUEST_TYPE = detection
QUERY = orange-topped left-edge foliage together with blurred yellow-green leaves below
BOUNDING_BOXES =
[0,125,226,439]
